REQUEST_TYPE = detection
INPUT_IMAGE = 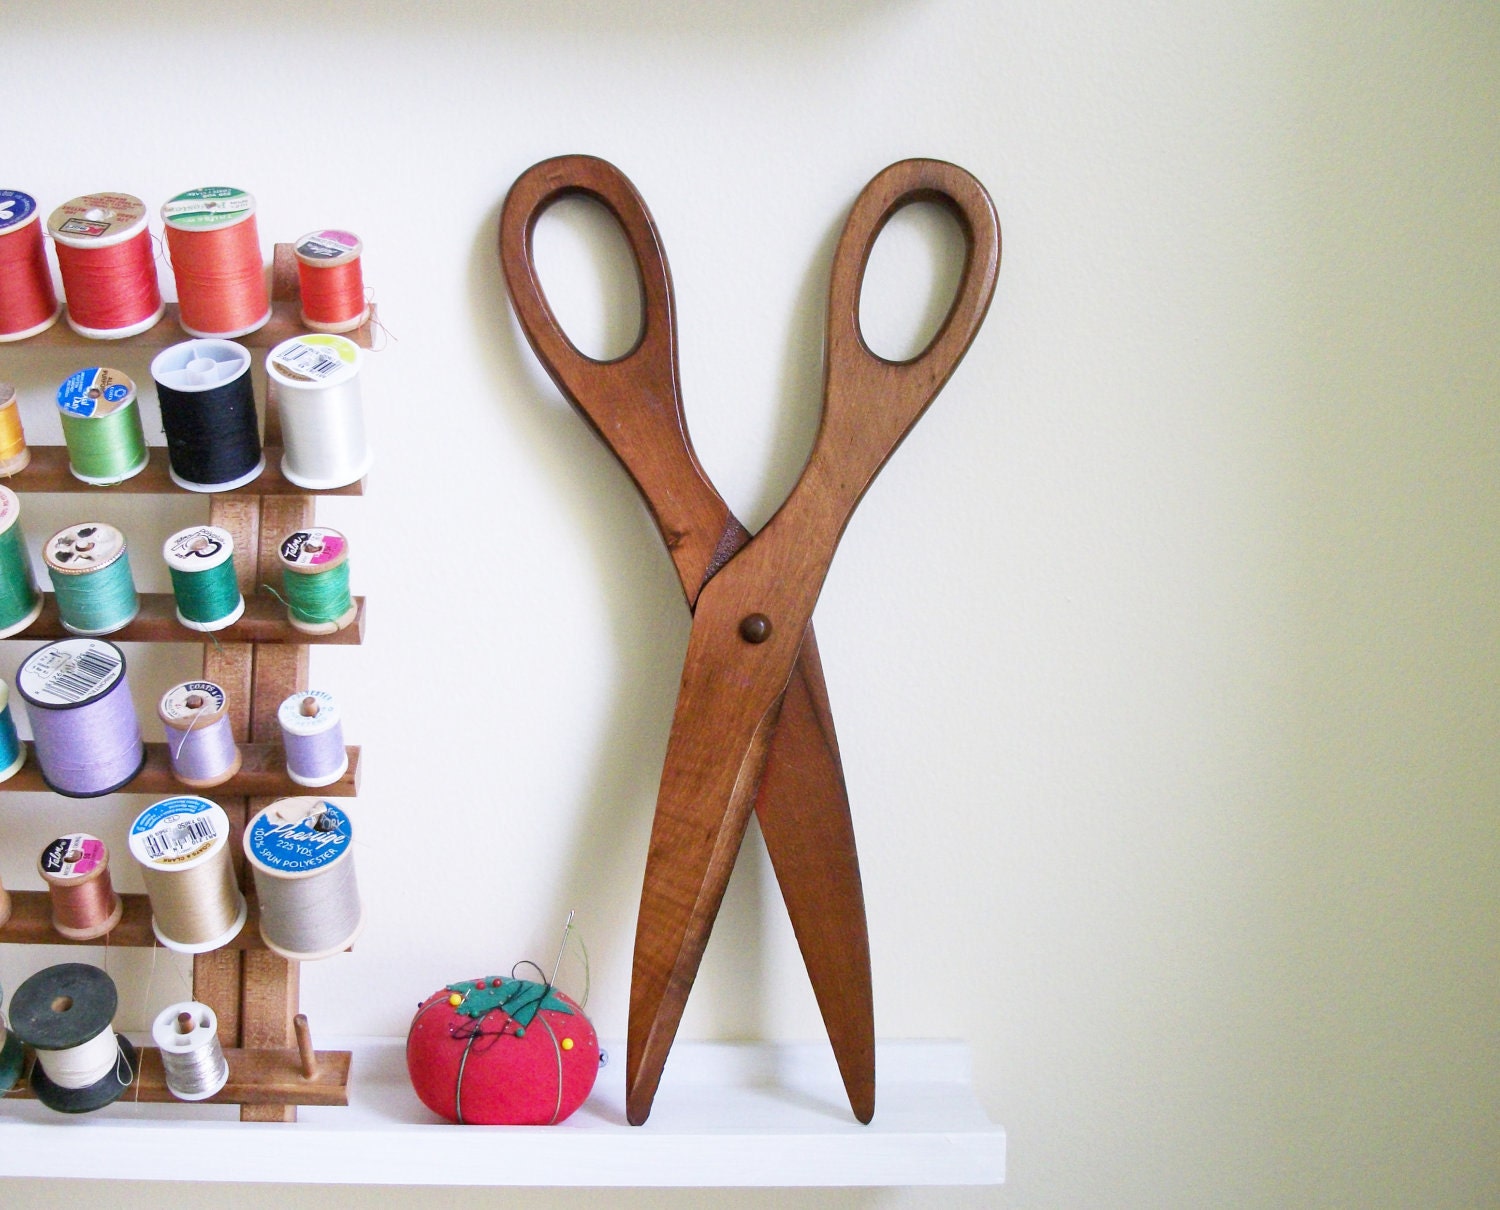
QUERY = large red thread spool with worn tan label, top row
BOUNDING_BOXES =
[47,193,167,340]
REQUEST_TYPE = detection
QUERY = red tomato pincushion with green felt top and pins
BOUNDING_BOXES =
[407,978,599,1126]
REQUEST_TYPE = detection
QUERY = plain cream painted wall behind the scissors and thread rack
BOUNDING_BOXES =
[0,0,1500,1207]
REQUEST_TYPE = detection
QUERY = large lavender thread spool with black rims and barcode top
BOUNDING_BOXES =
[17,639,146,798]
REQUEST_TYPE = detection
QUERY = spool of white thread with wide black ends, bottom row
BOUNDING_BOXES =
[11,963,137,1114]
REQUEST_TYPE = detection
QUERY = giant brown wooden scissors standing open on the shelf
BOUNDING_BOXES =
[500,156,1001,1125]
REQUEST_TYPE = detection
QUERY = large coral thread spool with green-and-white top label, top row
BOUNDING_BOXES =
[162,186,272,336]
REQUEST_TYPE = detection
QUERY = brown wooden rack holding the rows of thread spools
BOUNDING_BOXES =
[0,244,375,1122]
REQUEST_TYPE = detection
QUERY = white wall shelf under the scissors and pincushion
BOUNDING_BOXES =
[0,1038,1005,1188]
